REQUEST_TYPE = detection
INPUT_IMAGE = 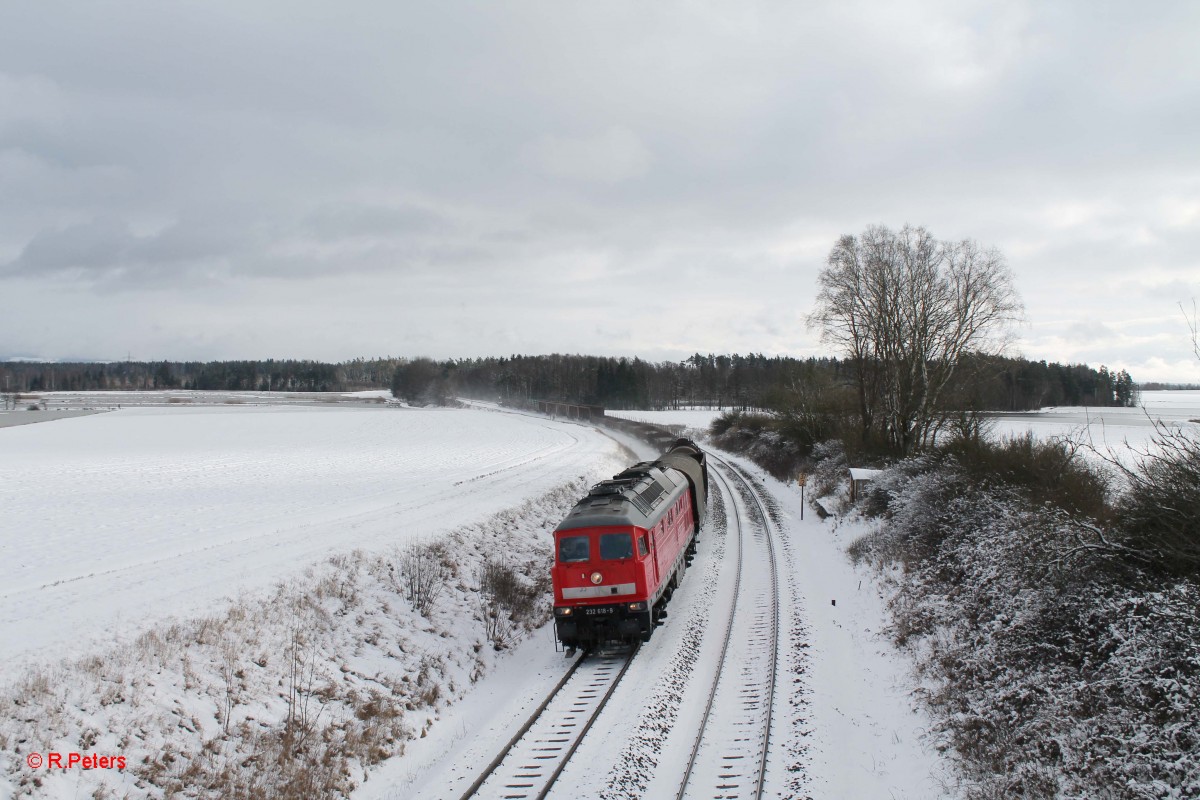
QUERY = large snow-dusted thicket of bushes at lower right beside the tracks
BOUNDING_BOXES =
[852,441,1200,800]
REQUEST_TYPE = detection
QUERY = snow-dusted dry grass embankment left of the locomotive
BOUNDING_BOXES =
[0,481,595,800]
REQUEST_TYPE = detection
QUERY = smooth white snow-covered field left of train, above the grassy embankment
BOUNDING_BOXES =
[0,405,617,678]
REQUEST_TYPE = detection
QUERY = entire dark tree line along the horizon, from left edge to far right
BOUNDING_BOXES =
[0,353,1136,422]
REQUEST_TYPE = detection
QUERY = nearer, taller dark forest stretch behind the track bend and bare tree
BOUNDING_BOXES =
[391,353,1136,411]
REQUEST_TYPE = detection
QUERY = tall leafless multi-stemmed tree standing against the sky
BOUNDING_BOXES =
[809,225,1021,453]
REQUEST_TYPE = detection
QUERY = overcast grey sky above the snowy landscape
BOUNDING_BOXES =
[0,0,1200,381]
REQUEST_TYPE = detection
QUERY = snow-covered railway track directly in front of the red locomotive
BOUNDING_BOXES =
[461,646,638,800]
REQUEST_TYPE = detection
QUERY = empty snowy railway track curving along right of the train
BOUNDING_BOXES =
[676,453,782,800]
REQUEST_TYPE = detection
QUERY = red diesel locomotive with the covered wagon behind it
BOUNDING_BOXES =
[552,439,708,650]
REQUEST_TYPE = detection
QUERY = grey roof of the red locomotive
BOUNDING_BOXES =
[556,462,688,530]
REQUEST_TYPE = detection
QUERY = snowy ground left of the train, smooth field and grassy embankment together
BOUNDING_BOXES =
[0,404,629,800]
